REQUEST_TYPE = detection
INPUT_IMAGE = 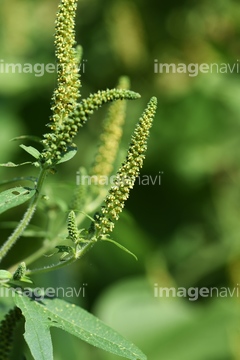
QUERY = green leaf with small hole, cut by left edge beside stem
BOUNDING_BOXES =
[0,186,36,214]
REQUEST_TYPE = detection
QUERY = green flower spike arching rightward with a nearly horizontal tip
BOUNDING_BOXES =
[41,89,140,165]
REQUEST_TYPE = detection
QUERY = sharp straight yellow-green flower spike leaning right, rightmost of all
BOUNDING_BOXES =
[95,97,157,236]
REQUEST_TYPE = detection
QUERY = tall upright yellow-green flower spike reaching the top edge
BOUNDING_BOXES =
[40,0,79,165]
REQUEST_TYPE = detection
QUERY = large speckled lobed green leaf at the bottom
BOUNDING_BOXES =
[15,293,147,360]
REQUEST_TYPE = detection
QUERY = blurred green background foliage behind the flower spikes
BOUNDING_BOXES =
[0,0,240,360]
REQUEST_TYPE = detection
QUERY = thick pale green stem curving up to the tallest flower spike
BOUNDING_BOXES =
[0,169,48,262]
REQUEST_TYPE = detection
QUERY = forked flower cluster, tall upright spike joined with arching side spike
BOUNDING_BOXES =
[39,0,142,168]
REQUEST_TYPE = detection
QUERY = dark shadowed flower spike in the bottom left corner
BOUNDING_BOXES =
[0,307,22,360]
